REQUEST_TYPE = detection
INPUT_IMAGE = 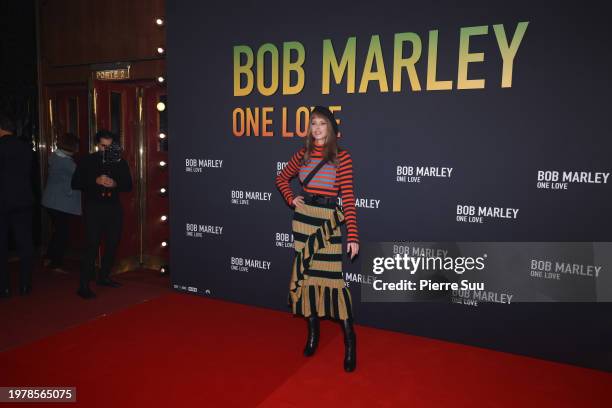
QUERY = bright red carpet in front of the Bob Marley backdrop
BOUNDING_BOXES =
[0,293,612,407]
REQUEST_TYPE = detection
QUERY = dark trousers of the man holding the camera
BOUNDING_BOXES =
[81,201,123,287]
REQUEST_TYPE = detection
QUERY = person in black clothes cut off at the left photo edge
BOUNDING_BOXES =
[0,113,34,297]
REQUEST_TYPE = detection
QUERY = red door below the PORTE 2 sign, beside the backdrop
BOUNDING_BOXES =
[93,81,168,271]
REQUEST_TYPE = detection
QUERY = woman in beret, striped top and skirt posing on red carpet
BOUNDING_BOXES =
[276,106,359,372]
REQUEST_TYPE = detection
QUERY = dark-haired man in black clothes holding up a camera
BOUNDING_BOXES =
[72,130,132,299]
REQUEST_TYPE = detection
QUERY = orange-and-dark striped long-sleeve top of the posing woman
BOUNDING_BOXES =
[276,145,359,242]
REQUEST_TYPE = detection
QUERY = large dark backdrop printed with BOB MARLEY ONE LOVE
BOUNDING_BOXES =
[166,0,612,369]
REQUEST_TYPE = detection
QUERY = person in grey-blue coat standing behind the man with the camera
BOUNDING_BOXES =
[42,133,81,272]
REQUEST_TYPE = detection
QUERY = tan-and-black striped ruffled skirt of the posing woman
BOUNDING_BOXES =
[289,204,352,320]
